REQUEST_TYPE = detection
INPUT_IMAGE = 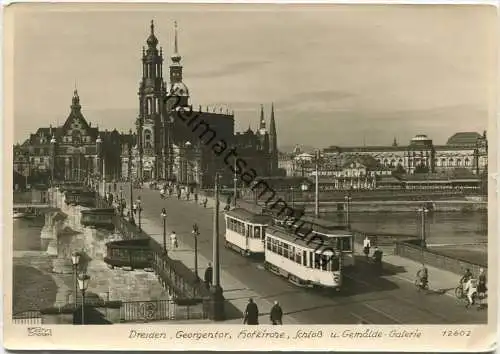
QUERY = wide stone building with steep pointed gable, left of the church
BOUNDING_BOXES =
[13,89,121,184]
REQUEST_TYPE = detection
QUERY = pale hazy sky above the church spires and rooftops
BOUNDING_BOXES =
[7,4,497,148]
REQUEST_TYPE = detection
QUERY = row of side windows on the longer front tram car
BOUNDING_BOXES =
[266,237,340,272]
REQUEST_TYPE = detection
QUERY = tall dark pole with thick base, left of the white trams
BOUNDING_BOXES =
[210,173,225,321]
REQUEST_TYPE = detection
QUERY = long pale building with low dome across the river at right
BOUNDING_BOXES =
[279,132,488,189]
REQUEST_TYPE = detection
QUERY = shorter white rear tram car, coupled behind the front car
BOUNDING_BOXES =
[225,208,272,256]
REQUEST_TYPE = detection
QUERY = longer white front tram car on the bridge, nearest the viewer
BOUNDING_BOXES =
[264,226,343,291]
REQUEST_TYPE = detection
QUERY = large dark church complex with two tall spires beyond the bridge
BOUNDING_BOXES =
[120,22,278,188]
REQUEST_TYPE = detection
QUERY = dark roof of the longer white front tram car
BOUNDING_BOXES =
[266,226,348,253]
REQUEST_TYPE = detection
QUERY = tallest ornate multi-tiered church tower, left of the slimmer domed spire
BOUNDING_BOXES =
[136,21,166,179]
